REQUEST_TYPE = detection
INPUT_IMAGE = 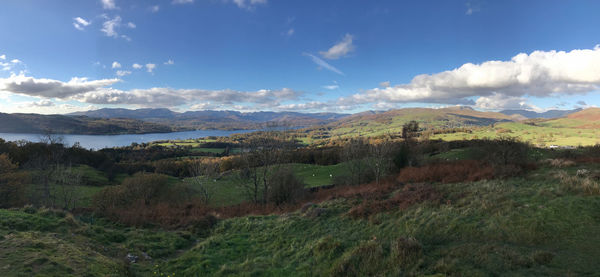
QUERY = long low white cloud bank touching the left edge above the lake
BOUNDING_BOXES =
[0,74,120,99]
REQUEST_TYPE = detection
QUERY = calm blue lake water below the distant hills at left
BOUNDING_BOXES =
[0,130,255,149]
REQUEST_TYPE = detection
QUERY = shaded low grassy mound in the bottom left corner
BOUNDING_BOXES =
[0,208,193,276]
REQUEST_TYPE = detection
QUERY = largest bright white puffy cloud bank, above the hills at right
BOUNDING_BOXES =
[348,46,600,105]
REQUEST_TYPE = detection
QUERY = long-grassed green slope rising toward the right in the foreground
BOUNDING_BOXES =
[160,165,600,276]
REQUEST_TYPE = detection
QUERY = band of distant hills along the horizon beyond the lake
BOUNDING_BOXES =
[0,107,599,136]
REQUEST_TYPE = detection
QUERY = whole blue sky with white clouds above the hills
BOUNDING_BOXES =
[0,0,600,114]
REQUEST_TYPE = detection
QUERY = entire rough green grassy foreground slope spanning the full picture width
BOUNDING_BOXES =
[0,166,600,276]
